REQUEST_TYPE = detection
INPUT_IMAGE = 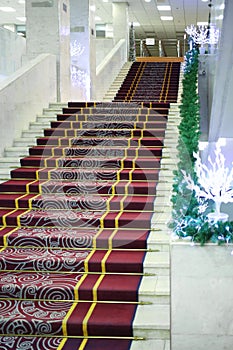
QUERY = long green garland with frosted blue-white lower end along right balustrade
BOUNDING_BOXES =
[169,48,233,245]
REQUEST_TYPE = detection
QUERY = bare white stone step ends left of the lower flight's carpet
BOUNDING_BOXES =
[0,103,67,182]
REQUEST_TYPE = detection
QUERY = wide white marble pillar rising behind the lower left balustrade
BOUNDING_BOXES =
[25,0,70,101]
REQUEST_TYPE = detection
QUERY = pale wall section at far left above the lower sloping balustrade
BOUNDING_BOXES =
[0,27,26,81]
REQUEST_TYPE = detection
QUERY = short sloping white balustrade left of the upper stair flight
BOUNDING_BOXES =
[95,39,127,101]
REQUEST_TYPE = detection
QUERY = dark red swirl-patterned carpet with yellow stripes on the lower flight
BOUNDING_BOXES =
[0,61,180,350]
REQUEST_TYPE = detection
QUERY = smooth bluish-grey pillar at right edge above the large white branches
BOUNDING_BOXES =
[209,0,233,142]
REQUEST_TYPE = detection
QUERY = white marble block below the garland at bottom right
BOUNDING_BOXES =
[171,242,233,350]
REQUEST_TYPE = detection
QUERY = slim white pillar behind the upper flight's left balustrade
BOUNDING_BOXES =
[112,1,129,57]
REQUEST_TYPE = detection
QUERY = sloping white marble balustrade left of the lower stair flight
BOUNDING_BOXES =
[0,54,57,155]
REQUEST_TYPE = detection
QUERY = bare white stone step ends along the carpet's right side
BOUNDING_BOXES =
[130,70,183,350]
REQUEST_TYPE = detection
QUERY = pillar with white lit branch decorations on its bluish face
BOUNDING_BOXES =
[70,0,96,101]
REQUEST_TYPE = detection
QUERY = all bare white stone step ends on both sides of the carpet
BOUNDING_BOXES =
[0,62,183,350]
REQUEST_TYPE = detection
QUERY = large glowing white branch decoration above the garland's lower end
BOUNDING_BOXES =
[182,145,233,214]
